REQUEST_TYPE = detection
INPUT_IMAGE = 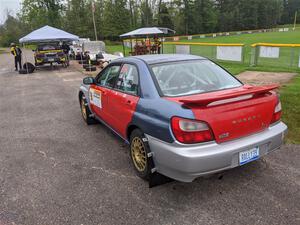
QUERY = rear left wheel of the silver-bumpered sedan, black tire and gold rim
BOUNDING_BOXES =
[129,129,154,180]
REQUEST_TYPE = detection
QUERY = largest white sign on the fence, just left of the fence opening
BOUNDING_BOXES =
[217,46,242,62]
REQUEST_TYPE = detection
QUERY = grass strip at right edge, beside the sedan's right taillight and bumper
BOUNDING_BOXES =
[280,75,300,144]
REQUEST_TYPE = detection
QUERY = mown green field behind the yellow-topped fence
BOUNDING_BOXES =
[170,27,300,72]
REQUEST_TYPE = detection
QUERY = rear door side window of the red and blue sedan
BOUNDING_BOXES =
[116,64,139,95]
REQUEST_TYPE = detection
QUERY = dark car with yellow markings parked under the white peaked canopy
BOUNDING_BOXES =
[34,43,68,66]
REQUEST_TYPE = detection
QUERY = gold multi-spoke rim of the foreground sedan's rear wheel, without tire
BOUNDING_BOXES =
[131,137,147,172]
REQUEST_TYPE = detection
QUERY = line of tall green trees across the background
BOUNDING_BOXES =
[0,0,300,45]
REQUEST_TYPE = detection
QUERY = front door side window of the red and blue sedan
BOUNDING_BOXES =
[96,65,120,87]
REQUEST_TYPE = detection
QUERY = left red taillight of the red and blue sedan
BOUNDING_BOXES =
[171,117,214,144]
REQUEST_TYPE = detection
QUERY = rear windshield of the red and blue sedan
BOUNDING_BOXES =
[151,60,242,97]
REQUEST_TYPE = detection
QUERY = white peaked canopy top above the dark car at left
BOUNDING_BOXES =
[19,25,79,43]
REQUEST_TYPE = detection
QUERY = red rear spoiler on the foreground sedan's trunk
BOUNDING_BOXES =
[179,84,279,106]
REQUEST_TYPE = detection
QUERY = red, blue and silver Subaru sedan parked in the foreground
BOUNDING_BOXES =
[79,55,287,182]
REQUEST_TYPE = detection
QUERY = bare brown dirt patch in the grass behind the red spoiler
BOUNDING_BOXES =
[237,71,297,85]
